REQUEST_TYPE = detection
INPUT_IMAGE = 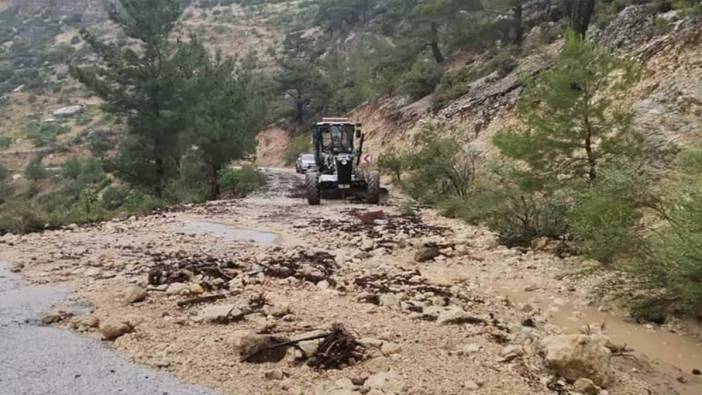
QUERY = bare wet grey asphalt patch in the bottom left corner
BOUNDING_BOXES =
[0,262,214,395]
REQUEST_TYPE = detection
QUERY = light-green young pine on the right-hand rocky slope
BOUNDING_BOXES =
[495,32,641,186]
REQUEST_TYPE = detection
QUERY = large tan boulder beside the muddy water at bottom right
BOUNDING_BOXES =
[541,335,612,388]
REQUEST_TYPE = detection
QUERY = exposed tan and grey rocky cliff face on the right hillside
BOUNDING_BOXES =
[353,6,702,167]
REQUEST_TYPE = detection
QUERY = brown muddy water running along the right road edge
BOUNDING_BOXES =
[499,285,702,395]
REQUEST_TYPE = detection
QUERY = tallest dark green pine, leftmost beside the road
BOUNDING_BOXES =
[71,0,187,196]
